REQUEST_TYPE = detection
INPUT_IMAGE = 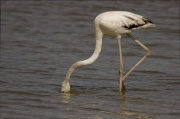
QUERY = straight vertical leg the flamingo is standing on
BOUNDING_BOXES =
[117,36,125,92]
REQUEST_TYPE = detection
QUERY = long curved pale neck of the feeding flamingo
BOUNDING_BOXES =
[64,33,103,82]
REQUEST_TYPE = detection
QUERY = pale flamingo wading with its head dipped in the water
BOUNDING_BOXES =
[61,11,155,93]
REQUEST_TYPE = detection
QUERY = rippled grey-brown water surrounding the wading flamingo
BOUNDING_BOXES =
[0,0,180,119]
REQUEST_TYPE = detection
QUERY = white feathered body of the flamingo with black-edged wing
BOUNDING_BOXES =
[95,11,155,37]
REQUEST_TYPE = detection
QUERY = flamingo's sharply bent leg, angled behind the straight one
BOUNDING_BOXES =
[122,34,151,81]
